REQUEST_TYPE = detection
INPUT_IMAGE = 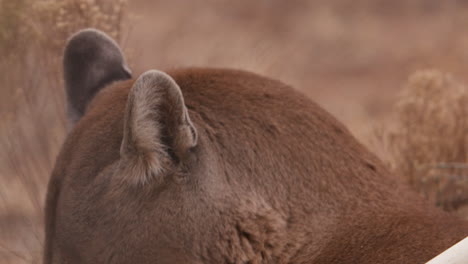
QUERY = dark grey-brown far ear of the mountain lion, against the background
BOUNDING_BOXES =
[63,29,131,127]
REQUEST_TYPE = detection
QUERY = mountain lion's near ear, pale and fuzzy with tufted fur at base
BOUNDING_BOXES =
[120,70,197,184]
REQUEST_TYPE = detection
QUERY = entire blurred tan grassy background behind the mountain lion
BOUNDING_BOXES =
[0,0,468,263]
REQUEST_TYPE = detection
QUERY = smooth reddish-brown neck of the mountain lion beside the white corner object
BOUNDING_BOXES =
[304,205,468,263]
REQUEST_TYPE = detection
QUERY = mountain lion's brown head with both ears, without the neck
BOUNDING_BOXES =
[48,27,380,264]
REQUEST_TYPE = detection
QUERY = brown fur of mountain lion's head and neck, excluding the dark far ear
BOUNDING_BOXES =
[44,29,468,264]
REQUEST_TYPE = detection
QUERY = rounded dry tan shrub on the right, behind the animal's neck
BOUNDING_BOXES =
[384,70,468,210]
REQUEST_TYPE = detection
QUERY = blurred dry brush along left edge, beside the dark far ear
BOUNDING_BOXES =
[0,0,126,263]
